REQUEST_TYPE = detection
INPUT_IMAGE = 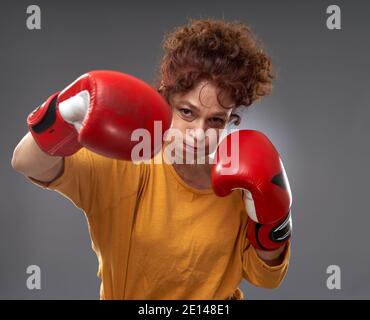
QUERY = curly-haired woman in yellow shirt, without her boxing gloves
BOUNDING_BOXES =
[12,19,290,299]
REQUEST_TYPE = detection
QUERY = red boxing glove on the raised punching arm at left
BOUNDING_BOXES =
[27,70,172,160]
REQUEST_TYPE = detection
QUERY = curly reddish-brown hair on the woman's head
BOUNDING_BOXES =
[156,18,275,107]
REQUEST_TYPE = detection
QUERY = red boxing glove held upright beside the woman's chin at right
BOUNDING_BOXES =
[211,130,292,250]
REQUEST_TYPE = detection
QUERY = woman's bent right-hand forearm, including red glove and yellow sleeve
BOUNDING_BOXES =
[212,130,292,288]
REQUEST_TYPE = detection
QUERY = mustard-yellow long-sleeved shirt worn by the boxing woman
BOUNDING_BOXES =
[29,148,290,300]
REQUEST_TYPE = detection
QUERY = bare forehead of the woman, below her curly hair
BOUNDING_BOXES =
[173,80,234,113]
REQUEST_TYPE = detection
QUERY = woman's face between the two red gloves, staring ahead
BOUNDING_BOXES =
[165,80,234,163]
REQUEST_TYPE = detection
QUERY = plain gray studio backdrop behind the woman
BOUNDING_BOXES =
[0,0,370,299]
